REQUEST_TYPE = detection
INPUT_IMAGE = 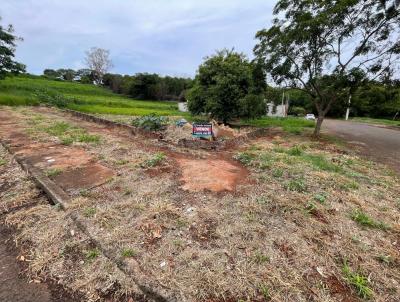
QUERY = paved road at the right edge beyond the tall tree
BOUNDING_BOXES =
[322,120,400,173]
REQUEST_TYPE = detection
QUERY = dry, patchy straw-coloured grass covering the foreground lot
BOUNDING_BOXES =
[0,107,400,301]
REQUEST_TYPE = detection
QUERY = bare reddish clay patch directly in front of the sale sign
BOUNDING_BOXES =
[176,158,248,192]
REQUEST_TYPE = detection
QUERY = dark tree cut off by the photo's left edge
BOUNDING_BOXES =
[0,17,25,79]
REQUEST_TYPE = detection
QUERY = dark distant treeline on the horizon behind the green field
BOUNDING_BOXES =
[43,69,193,101]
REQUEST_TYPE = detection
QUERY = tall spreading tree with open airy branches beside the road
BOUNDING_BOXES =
[254,0,400,136]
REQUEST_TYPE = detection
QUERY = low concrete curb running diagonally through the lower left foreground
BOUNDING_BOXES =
[0,140,180,302]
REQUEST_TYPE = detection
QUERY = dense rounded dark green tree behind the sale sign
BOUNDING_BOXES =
[187,50,266,124]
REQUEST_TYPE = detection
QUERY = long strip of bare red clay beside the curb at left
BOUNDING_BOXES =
[0,110,114,190]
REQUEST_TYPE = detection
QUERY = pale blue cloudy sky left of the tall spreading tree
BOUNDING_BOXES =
[0,0,275,76]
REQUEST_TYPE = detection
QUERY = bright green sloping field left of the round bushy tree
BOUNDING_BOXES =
[0,76,183,116]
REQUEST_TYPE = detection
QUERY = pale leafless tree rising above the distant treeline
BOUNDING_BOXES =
[85,47,113,85]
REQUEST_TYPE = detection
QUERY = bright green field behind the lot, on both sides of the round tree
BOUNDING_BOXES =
[0,75,314,133]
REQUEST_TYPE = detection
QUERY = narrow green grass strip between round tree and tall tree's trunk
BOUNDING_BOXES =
[242,117,315,134]
